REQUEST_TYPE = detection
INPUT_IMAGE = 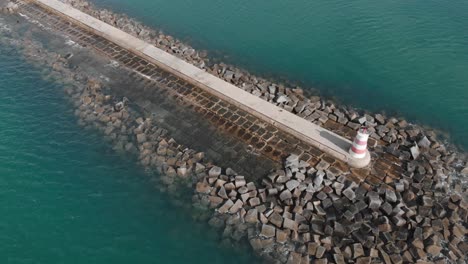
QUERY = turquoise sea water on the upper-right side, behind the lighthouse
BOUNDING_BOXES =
[93,0,468,149]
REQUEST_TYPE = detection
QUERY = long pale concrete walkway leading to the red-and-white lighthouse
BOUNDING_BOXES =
[25,0,370,168]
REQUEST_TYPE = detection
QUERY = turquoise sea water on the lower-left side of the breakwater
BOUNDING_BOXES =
[0,46,252,264]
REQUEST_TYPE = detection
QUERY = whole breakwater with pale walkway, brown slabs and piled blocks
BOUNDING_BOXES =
[0,0,467,263]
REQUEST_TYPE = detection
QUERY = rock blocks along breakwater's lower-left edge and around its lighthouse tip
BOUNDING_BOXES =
[1,2,468,264]
